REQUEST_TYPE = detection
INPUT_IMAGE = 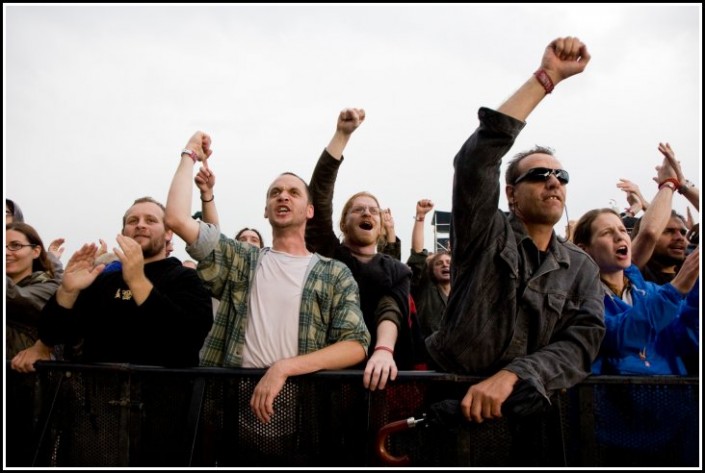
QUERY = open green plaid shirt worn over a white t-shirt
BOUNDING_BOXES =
[186,222,370,367]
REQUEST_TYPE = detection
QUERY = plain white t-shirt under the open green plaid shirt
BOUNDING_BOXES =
[242,250,313,368]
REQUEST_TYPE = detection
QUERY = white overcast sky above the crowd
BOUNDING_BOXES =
[3,4,702,262]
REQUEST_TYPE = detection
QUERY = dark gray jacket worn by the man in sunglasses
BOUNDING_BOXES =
[426,108,605,396]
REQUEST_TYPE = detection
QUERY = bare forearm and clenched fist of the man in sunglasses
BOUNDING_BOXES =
[498,36,590,121]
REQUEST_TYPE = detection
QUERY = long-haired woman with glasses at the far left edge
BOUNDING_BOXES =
[5,222,59,360]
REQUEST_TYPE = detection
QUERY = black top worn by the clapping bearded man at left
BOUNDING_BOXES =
[39,258,213,367]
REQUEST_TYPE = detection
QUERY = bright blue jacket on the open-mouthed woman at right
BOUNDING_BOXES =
[592,265,699,375]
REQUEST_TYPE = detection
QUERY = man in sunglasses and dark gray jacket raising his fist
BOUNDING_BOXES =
[426,37,605,422]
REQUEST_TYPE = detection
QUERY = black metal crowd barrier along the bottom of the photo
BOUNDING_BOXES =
[5,362,701,467]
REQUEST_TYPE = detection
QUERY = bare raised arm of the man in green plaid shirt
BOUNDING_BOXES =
[165,131,213,245]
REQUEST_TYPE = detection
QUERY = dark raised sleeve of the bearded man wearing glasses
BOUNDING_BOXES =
[306,149,342,258]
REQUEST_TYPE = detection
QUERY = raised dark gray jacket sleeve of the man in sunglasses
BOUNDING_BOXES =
[450,108,525,262]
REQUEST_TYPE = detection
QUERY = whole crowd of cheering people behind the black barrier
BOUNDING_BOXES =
[5,37,700,450]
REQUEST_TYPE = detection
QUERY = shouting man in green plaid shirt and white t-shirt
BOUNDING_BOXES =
[166,132,370,423]
